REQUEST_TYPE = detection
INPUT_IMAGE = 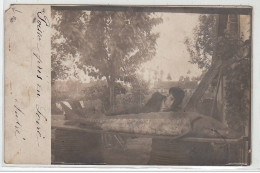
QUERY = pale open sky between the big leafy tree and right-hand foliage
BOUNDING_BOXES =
[140,13,201,81]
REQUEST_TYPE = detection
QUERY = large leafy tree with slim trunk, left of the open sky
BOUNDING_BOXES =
[51,10,162,108]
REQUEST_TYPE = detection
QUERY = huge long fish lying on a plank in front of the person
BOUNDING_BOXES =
[66,112,240,138]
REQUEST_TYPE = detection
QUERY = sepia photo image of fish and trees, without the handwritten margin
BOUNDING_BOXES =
[51,6,252,165]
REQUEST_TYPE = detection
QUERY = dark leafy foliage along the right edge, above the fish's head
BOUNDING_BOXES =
[225,39,251,133]
